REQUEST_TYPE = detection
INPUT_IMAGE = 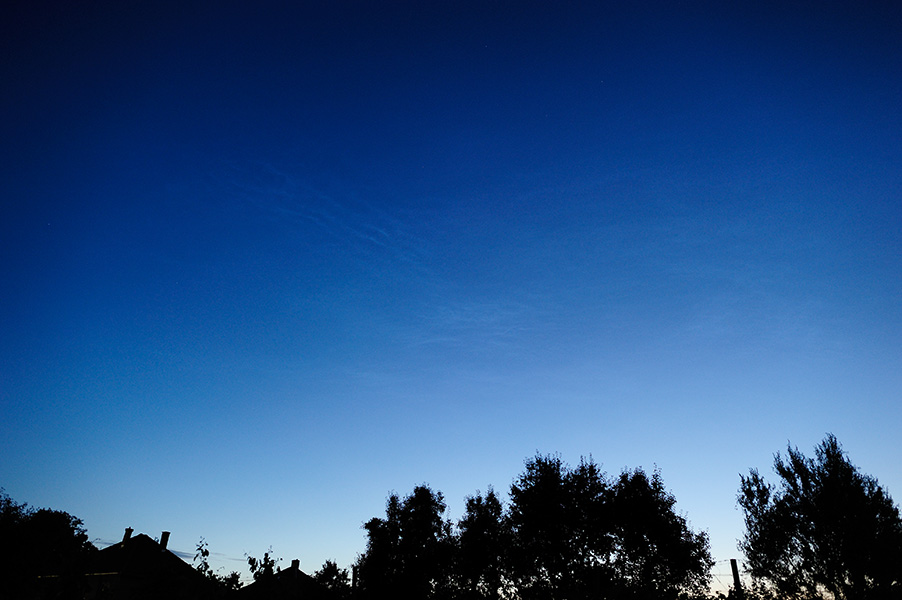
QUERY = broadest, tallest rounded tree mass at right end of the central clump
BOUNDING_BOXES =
[509,456,713,600]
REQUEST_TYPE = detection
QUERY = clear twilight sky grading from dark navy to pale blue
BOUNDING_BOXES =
[0,0,902,583]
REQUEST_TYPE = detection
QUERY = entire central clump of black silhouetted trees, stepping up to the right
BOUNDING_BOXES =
[357,456,712,600]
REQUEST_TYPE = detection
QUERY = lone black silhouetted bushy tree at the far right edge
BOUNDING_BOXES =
[739,434,902,600]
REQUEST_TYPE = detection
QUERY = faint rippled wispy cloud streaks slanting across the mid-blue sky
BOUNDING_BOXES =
[207,163,564,352]
